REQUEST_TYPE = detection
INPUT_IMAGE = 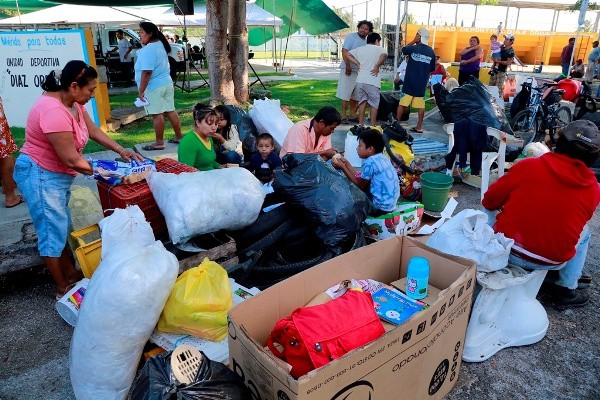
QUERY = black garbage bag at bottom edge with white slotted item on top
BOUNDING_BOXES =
[130,352,251,400]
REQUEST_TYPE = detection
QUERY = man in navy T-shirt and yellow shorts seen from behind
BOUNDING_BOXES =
[396,28,435,133]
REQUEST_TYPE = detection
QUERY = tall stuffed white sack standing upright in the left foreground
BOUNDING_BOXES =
[69,206,179,400]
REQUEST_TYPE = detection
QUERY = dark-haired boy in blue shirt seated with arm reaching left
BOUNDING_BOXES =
[331,129,400,216]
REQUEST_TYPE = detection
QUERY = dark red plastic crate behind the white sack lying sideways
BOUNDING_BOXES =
[97,158,197,237]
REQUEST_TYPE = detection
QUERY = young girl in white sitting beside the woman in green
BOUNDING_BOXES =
[214,105,244,164]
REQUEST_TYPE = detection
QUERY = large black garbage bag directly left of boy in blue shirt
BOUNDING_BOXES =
[273,153,374,254]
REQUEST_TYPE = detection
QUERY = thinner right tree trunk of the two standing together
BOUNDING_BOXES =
[229,0,248,103]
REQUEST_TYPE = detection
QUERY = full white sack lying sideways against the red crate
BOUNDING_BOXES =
[147,168,265,244]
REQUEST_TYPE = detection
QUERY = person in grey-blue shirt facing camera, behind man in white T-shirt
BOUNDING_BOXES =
[335,21,373,124]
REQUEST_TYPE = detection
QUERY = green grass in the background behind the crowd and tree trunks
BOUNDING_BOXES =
[11,79,433,153]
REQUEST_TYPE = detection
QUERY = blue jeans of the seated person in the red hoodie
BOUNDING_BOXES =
[484,210,591,289]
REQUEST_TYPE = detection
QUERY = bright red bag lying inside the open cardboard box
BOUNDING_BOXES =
[267,290,385,379]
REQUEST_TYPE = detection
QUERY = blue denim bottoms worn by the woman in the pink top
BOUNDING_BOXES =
[14,153,75,257]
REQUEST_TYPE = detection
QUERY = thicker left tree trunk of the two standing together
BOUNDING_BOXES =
[206,0,236,104]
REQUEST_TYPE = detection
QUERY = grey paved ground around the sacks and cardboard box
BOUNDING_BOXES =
[0,60,600,400]
